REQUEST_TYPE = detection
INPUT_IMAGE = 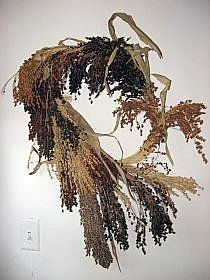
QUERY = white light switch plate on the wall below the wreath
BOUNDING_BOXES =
[20,218,40,251]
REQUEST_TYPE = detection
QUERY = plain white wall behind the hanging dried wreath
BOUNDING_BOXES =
[0,0,210,280]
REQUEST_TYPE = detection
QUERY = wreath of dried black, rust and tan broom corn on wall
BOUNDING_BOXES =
[2,13,207,268]
